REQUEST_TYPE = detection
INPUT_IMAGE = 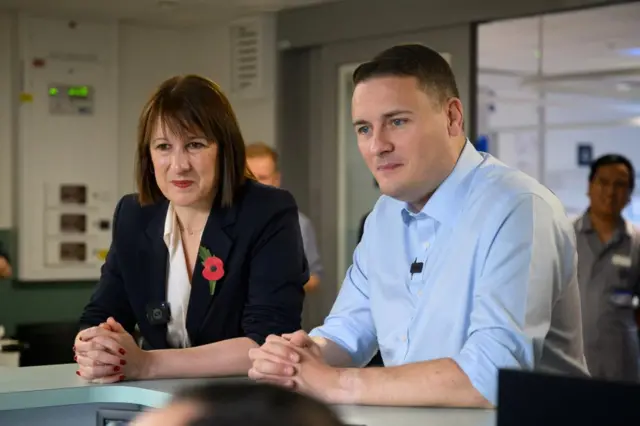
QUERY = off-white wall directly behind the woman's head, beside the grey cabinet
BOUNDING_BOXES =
[0,11,276,228]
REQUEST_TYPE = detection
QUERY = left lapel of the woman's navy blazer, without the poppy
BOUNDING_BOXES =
[139,202,169,349]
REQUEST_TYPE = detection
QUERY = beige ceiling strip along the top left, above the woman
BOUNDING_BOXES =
[0,0,342,26]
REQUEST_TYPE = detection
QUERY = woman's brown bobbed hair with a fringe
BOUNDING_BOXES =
[135,75,252,210]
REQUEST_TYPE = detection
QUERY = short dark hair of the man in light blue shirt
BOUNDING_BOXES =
[353,44,460,105]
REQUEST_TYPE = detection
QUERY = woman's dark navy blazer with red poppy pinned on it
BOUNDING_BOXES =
[80,180,309,349]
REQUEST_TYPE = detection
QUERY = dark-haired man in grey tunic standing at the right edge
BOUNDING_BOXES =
[575,155,640,381]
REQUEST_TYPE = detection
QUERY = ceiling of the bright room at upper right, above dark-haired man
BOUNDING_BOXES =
[478,2,640,104]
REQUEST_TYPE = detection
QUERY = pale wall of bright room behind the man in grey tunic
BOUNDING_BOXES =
[479,76,640,222]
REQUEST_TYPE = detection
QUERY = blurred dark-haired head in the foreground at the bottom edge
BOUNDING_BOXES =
[131,383,345,426]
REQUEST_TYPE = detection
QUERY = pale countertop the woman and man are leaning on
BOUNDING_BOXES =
[0,364,496,426]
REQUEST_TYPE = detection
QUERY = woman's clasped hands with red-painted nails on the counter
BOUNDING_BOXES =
[73,317,149,383]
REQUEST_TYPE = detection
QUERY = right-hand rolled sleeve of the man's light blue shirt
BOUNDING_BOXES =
[453,194,576,405]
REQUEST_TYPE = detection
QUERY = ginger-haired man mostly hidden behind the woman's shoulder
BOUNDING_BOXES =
[246,142,322,293]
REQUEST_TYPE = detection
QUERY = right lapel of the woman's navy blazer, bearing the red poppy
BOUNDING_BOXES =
[187,201,237,345]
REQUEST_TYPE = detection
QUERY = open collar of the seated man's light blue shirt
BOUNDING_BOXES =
[402,139,483,225]
